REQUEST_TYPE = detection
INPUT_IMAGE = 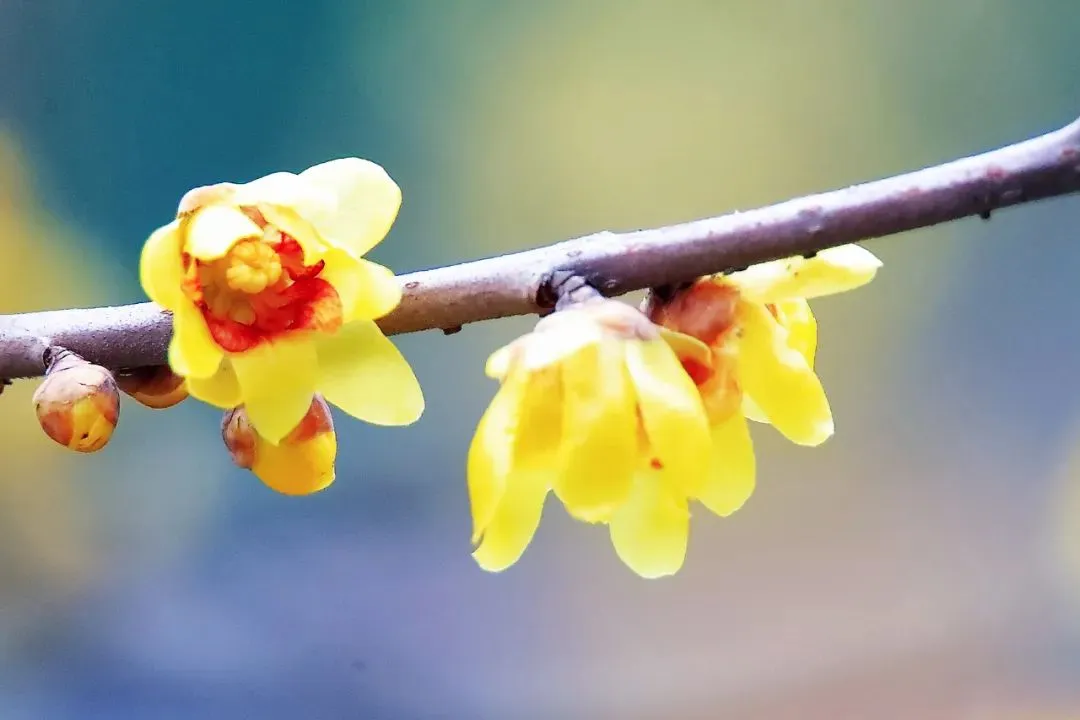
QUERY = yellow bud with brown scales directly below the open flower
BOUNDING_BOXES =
[221,395,337,495]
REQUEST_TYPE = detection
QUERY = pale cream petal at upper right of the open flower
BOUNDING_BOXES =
[300,158,402,255]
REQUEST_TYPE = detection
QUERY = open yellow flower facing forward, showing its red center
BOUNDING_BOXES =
[139,158,423,443]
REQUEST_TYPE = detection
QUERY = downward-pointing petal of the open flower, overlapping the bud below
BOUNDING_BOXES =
[230,337,319,445]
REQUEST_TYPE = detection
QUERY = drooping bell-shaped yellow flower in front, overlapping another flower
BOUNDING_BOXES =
[468,300,714,578]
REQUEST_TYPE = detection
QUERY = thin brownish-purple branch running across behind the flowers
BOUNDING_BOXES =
[0,114,1080,378]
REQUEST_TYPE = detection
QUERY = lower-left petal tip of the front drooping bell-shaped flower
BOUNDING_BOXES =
[473,462,550,572]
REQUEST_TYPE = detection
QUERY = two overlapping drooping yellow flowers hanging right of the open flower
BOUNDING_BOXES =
[468,245,880,578]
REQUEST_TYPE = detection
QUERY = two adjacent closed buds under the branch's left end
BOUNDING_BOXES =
[33,348,188,452]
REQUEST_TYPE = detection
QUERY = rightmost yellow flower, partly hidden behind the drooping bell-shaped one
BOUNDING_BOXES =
[647,245,881,444]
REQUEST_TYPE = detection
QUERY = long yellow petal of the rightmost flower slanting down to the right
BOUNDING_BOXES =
[738,302,833,446]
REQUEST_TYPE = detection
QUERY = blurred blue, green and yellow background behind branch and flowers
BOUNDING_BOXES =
[0,0,1080,720]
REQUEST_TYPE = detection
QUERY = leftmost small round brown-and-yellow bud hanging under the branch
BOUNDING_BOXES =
[33,348,120,452]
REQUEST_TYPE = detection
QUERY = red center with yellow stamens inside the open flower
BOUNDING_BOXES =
[184,213,341,352]
